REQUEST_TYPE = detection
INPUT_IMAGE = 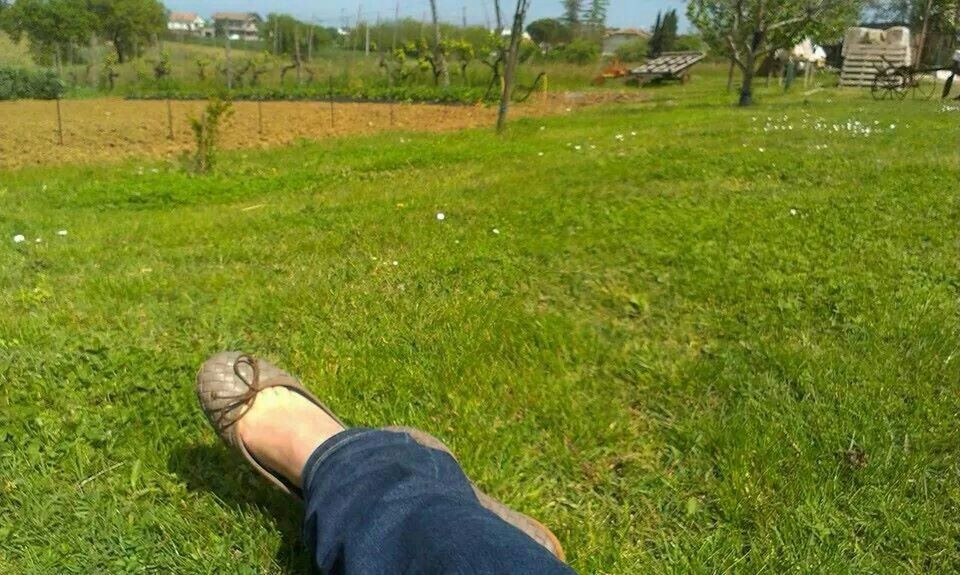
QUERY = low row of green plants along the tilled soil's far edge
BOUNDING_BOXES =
[127,86,499,104]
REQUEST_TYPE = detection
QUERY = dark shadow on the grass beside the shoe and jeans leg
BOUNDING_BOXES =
[167,445,314,575]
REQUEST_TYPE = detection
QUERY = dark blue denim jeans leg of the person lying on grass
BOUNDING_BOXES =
[303,428,573,575]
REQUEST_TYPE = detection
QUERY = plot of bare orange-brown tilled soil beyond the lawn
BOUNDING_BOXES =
[0,92,641,168]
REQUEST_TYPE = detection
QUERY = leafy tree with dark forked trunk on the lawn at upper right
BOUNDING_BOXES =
[687,0,863,106]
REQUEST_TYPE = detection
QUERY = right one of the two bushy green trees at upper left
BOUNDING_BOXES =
[90,0,167,63]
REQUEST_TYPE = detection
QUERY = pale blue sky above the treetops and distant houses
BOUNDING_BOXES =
[164,0,687,28]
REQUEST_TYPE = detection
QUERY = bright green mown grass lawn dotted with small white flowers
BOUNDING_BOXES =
[0,80,960,575]
